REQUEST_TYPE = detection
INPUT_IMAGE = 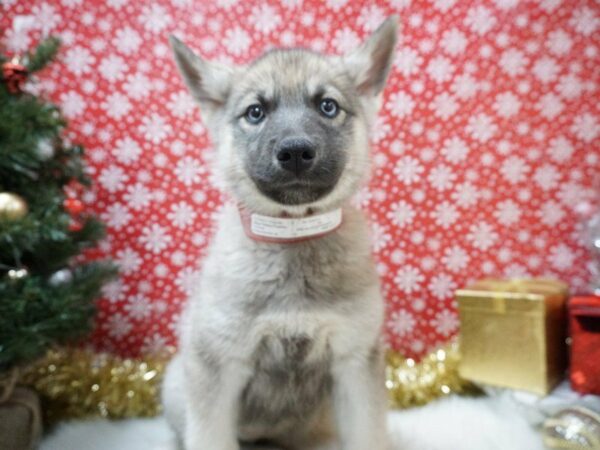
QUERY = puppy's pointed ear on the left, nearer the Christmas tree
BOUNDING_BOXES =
[169,35,233,115]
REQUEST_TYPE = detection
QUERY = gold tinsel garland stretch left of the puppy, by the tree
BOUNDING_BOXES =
[20,349,172,422]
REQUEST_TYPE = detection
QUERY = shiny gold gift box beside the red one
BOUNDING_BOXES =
[456,279,568,394]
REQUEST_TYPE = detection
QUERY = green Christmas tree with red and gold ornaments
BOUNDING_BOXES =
[0,38,115,373]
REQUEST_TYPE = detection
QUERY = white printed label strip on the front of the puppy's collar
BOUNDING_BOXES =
[250,208,342,239]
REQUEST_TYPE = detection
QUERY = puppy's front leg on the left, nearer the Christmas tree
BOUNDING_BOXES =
[184,359,249,450]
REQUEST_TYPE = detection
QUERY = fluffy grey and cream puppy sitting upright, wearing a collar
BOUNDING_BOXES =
[163,17,397,450]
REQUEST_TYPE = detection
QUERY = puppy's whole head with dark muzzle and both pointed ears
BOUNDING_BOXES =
[171,18,397,214]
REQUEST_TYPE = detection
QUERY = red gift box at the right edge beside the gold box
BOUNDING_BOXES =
[569,296,600,394]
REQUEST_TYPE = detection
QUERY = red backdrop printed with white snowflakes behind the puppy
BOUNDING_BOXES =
[0,0,600,355]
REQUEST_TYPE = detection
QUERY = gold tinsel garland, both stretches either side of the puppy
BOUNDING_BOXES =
[21,343,476,422]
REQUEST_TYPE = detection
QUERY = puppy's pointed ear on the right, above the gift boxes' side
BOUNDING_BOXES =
[344,16,398,96]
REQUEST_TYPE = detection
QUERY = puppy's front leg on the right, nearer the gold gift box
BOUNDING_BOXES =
[333,356,390,450]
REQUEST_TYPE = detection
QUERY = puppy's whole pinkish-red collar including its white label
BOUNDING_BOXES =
[239,207,342,244]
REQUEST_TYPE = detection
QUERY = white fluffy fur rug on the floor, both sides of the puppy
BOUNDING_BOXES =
[41,397,544,450]
